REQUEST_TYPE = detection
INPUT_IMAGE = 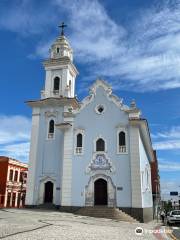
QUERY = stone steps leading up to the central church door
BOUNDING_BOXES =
[75,206,138,222]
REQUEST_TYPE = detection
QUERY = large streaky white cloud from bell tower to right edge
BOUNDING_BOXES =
[38,0,180,91]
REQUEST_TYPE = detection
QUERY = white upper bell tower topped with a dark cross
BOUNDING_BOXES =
[41,23,78,99]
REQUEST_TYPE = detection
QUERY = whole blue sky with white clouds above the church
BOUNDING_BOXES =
[0,0,180,199]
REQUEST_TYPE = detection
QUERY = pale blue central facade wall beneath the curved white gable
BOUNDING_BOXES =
[72,87,131,207]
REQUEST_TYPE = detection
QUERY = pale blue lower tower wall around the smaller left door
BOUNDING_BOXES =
[26,106,64,205]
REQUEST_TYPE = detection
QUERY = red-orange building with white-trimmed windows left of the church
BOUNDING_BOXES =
[0,156,28,208]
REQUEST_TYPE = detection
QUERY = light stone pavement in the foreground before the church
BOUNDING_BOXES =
[0,209,169,240]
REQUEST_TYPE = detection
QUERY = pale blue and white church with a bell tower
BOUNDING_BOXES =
[26,25,153,222]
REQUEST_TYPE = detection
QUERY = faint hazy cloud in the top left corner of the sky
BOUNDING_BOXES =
[0,0,58,36]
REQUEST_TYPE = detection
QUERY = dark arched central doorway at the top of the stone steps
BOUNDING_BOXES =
[94,178,107,205]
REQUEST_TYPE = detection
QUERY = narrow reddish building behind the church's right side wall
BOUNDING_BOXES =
[151,150,161,217]
